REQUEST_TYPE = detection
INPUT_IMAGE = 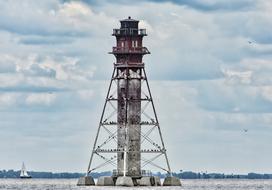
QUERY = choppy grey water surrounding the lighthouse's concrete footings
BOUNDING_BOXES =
[0,179,272,190]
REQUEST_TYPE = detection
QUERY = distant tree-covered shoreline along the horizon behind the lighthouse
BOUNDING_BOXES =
[0,170,272,179]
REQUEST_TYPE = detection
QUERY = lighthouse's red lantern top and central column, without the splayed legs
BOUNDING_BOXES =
[111,17,150,178]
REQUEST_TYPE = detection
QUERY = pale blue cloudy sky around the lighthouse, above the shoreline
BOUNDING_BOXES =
[0,0,272,173]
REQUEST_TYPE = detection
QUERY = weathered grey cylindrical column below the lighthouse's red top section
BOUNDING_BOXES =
[117,68,141,176]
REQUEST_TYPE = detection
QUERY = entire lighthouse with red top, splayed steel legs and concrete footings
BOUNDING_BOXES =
[78,17,180,186]
